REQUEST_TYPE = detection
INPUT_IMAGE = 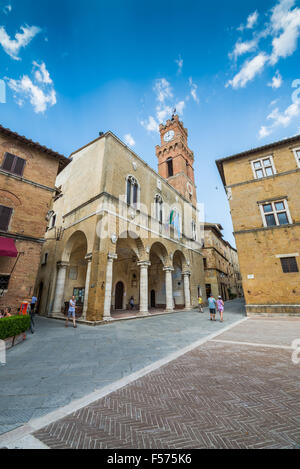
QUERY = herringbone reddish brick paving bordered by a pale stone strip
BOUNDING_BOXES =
[35,328,300,449]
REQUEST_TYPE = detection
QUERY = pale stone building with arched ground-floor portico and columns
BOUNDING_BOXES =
[37,116,205,322]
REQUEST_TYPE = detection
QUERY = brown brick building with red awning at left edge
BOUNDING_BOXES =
[0,126,68,312]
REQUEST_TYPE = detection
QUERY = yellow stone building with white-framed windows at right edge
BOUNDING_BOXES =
[217,135,300,315]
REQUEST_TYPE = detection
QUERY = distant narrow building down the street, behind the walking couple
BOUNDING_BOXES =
[202,223,242,301]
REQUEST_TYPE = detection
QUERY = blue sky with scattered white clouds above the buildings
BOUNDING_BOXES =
[0,0,300,245]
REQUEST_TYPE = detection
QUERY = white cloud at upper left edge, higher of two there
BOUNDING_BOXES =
[0,26,41,60]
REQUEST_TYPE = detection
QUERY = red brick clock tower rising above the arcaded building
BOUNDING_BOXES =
[156,115,197,205]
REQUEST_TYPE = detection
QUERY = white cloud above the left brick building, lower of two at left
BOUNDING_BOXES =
[8,62,57,114]
